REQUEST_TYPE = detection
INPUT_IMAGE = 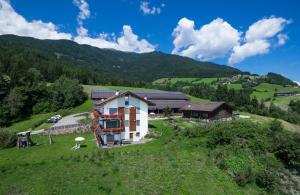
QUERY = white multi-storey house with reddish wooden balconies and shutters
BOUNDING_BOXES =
[93,91,154,145]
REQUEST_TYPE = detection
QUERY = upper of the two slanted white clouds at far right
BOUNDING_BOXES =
[245,16,291,42]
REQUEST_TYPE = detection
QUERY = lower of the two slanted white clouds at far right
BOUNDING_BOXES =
[228,40,270,64]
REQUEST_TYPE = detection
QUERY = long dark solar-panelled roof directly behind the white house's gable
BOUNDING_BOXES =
[91,90,188,101]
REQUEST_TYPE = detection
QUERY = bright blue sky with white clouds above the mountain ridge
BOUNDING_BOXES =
[0,0,300,81]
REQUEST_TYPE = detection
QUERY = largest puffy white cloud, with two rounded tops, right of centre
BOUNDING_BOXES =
[172,18,240,60]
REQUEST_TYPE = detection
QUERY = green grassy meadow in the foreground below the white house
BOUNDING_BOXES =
[0,121,261,194]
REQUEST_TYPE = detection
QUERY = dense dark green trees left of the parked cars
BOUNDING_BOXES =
[0,71,87,127]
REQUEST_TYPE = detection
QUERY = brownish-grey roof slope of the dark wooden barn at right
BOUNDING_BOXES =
[181,102,225,112]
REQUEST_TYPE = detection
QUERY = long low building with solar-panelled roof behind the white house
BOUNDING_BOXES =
[91,90,189,113]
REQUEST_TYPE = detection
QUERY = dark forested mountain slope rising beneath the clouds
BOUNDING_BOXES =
[0,35,241,83]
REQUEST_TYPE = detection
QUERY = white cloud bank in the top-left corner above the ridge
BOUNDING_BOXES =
[0,0,72,39]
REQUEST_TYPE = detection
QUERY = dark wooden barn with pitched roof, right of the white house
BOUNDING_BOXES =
[181,102,232,121]
